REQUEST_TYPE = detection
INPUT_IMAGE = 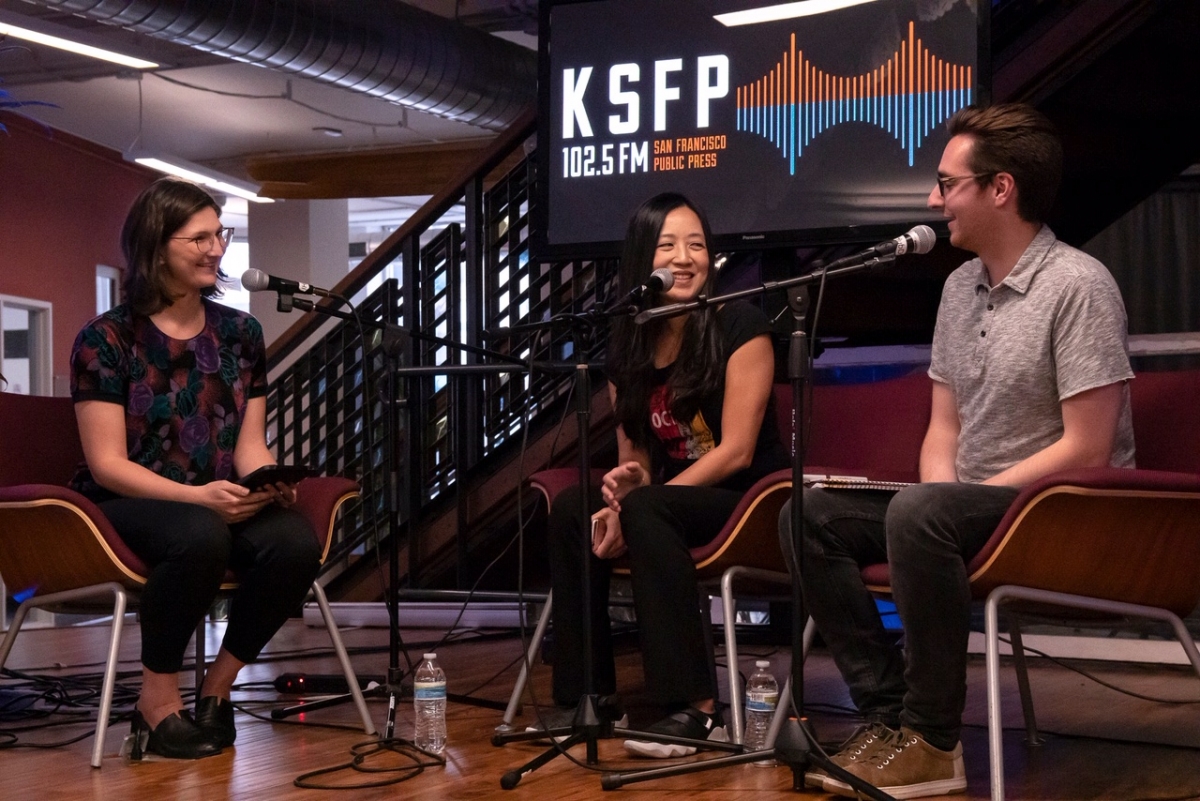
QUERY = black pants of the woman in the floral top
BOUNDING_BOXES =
[100,498,320,673]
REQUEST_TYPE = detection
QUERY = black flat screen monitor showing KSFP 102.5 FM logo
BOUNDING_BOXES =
[533,0,990,258]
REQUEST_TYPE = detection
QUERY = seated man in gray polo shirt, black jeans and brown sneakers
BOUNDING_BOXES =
[780,104,1134,799]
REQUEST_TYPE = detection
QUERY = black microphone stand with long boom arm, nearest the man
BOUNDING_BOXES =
[600,253,895,801]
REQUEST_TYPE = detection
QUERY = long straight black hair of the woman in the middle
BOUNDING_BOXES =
[607,192,725,447]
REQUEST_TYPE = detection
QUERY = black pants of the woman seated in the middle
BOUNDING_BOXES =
[547,484,742,706]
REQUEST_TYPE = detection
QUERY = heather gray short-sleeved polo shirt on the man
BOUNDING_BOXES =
[929,225,1134,483]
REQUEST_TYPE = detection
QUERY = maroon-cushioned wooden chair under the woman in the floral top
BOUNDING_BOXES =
[0,393,376,767]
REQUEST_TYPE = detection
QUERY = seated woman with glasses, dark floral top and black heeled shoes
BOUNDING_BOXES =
[71,179,320,759]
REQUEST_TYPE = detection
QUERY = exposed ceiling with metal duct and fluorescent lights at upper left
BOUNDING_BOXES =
[0,0,536,197]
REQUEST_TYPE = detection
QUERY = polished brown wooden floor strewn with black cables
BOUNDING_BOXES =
[0,621,1200,801]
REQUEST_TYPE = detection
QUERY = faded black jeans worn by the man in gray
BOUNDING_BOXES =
[779,483,1018,749]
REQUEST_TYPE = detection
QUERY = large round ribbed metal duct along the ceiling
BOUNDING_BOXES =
[28,0,538,131]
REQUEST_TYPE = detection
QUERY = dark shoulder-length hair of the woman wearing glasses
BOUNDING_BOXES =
[121,177,228,317]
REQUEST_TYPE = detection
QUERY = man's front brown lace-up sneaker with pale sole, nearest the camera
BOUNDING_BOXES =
[823,727,967,799]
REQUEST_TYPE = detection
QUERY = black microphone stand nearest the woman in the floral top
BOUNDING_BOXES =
[271,291,540,733]
